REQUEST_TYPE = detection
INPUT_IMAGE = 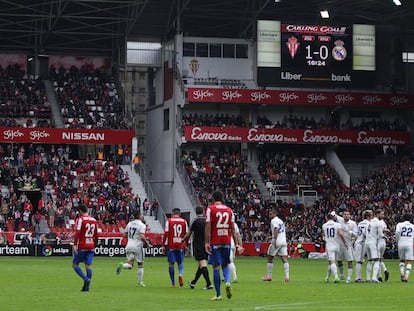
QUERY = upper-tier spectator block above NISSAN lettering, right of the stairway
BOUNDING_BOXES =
[50,65,132,129]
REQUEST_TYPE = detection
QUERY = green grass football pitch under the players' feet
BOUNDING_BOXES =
[0,257,414,311]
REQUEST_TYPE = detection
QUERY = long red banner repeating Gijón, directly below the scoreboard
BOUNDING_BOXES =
[187,88,414,109]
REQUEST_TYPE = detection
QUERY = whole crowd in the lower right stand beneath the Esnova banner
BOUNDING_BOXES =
[182,146,414,254]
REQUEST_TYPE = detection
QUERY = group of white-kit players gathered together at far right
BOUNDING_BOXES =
[322,210,414,283]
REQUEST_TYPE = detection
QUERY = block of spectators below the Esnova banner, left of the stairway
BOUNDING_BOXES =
[181,146,268,242]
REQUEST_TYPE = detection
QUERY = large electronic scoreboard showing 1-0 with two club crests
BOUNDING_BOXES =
[257,21,375,87]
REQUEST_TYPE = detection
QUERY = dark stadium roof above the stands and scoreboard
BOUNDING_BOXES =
[0,0,414,55]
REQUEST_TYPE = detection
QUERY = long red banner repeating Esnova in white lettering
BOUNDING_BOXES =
[184,126,410,145]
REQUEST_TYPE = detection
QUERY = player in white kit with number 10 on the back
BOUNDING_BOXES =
[322,212,347,283]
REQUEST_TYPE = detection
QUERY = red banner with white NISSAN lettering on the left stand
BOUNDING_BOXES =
[0,127,135,145]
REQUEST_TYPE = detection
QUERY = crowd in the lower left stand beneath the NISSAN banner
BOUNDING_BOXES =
[0,145,141,236]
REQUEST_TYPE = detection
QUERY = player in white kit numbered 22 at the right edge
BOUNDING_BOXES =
[395,214,414,282]
